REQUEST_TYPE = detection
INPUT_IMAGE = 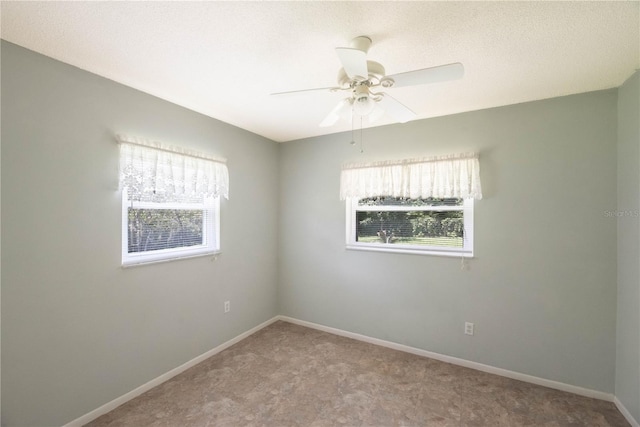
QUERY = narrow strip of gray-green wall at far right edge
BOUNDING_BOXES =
[616,72,640,422]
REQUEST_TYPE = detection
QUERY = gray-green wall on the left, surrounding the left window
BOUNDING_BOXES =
[1,42,278,426]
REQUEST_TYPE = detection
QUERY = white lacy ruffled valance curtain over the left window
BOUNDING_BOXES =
[117,135,229,203]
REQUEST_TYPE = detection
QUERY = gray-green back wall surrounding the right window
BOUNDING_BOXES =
[278,89,617,393]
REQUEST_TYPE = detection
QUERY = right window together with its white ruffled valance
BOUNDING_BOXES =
[340,153,482,257]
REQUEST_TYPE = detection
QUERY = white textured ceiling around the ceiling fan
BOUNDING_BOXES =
[0,1,640,142]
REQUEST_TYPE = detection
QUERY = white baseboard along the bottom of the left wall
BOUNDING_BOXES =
[63,316,279,427]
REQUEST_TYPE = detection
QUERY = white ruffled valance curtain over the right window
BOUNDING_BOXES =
[340,153,482,200]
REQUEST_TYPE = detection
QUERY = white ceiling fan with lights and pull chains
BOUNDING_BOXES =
[272,36,464,127]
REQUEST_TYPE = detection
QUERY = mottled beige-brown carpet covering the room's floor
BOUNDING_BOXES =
[88,322,629,427]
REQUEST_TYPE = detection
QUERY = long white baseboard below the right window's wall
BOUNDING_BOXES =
[278,316,616,404]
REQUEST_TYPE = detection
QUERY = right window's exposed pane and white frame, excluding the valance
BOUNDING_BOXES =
[347,197,473,256]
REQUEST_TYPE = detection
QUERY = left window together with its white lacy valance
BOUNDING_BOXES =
[118,136,229,266]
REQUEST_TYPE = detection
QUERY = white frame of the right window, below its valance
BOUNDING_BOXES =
[345,197,474,258]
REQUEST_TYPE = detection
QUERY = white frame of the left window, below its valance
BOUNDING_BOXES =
[121,188,220,267]
